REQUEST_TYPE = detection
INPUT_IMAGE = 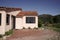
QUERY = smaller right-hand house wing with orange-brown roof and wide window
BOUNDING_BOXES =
[15,11,38,29]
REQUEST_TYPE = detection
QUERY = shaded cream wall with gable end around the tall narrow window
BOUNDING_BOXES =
[5,11,20,31]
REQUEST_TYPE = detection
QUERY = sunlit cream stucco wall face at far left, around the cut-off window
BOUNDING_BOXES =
[0,11,6,34]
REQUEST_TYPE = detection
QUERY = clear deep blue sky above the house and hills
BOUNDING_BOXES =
[0,0,60,15]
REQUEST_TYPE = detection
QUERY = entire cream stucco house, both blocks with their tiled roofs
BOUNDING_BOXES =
[0,7,38,35]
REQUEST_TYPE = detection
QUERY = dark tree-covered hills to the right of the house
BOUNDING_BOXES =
[38,14,60,23]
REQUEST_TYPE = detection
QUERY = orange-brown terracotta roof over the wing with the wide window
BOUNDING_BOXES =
[16,11,38,17]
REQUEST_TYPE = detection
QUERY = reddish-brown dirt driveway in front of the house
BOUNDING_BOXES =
[7,29,55,40]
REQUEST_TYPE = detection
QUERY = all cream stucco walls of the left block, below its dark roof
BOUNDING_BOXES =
[0,11,21,34]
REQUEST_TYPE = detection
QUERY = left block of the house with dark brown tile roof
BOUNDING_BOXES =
[0,7,22,34]
